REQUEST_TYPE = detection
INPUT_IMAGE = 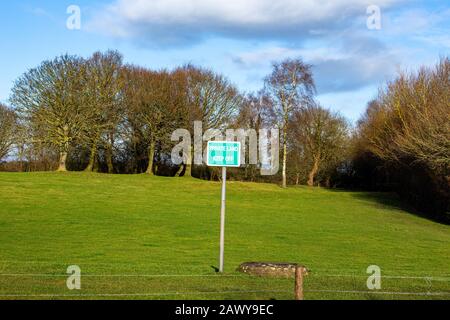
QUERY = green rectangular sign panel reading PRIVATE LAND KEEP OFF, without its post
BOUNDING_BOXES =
[206,141,241,167]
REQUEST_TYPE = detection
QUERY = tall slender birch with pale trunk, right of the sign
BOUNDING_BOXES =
[265,59,315,188]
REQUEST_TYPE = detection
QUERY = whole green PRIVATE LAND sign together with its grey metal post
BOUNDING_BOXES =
[207,141,241,273]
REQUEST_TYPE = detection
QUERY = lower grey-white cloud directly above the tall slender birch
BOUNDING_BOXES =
[232,35,399,94]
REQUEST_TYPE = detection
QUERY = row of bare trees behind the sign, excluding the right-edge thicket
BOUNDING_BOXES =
[2,51,349,187]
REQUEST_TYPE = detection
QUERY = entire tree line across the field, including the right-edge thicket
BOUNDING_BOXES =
[0,51,450,217]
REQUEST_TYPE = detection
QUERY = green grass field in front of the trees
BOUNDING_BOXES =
[0,173,450,299]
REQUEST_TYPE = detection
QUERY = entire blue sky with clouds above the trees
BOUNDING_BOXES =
[0,0,450,121]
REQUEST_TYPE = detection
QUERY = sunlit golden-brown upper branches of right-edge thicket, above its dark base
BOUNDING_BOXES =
[359,58,450,175]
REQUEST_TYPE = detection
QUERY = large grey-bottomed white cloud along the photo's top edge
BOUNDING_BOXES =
[90,0,402,46]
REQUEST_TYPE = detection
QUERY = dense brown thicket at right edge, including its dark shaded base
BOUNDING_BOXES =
[351,58,450,220]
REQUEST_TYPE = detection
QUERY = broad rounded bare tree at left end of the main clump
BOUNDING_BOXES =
[11,55,91,171]
